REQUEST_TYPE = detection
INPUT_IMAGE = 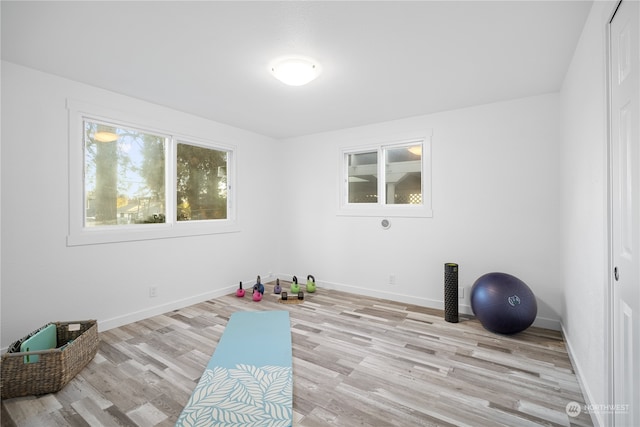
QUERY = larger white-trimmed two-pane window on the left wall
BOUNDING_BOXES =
[67,100,237,245]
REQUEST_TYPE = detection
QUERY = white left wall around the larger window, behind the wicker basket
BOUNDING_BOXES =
[1,62,279,347]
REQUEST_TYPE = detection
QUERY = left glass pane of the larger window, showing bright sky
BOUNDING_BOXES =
[84,120,166,227]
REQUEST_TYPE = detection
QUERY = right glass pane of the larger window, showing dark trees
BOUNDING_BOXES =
[176,143,228,221]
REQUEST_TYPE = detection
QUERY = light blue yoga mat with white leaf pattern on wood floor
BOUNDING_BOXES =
[176,311,293,427]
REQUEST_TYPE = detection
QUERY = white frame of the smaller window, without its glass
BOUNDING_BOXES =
[338,130,433,218]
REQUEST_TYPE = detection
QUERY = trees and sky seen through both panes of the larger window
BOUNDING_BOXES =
[84,120,230,227]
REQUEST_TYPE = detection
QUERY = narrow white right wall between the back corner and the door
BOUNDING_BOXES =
[560,1,617,425]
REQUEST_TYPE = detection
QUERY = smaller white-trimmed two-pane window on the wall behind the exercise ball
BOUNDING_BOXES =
[340,137,432,217]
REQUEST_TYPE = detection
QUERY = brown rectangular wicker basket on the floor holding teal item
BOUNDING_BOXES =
[0,320,100,399]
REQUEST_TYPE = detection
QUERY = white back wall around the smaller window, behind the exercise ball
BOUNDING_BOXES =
[279,94,562,328]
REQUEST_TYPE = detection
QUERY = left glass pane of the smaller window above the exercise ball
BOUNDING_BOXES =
[347,151,378,203]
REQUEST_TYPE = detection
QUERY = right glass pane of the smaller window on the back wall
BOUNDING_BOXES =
[384,144,422,205]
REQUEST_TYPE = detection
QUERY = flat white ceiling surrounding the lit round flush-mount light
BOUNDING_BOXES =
[1,0,591,138]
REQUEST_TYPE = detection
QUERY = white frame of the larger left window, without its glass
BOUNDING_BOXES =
[67,100,240,246]
